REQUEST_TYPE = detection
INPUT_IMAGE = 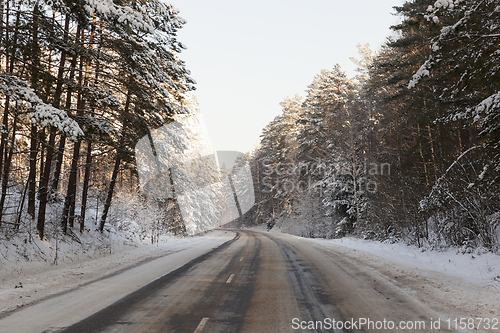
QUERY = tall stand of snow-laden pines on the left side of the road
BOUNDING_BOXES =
[0,0,194,239]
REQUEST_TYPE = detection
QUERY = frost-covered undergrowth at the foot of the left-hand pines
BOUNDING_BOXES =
[0,185,174,266]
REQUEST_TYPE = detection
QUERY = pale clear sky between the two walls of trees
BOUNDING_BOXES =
[174,0,403,152]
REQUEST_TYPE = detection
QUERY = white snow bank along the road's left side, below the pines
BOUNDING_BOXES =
[0,228,230,317]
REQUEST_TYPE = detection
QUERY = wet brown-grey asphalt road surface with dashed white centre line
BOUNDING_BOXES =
[47,230,458,333]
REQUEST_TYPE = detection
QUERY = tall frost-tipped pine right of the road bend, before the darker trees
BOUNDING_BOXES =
[298,65,362,237]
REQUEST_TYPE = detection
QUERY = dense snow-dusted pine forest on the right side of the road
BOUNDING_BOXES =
[247,0,500,249]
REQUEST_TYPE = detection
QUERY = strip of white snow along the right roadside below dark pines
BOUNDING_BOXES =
[315,237,500,287]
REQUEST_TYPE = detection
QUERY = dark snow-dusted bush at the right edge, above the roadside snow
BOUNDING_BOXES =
[420,146,500,249]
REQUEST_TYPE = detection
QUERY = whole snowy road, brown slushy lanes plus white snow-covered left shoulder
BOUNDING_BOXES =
[0,230,498,333]
